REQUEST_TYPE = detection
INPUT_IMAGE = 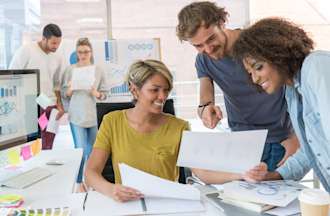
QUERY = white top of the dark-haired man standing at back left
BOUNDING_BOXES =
[9,42,64,104]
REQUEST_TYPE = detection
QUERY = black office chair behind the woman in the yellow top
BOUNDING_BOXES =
[96,99,190,184]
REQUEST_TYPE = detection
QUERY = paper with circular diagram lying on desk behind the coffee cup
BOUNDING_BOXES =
[223,180,304,207]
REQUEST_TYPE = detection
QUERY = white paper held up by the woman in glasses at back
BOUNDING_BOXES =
[71,65,95,90]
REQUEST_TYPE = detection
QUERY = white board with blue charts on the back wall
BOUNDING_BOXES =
[58,39,161,100]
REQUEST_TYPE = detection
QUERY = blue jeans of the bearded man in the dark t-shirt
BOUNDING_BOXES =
[261,143,285,171]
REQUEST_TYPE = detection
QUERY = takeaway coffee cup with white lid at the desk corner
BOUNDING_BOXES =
[298,189,330,216]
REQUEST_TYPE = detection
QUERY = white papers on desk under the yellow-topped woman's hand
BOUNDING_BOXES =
[84,164,205,216]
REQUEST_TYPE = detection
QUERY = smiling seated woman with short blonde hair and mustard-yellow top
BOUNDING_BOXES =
[85,60,189,201]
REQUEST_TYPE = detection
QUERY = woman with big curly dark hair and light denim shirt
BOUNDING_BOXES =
[233,18,330,192]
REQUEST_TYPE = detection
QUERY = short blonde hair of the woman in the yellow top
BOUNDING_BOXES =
[126,59,173,91]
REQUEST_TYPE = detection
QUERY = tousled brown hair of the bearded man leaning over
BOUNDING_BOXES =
[176,1,228,41]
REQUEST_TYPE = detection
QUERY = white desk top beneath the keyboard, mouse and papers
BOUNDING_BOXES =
[0,149,261,216]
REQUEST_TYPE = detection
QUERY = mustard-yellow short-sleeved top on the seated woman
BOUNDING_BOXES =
[94,110,189,183]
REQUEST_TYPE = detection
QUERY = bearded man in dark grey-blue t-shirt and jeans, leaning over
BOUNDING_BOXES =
[177,1,299,183]
